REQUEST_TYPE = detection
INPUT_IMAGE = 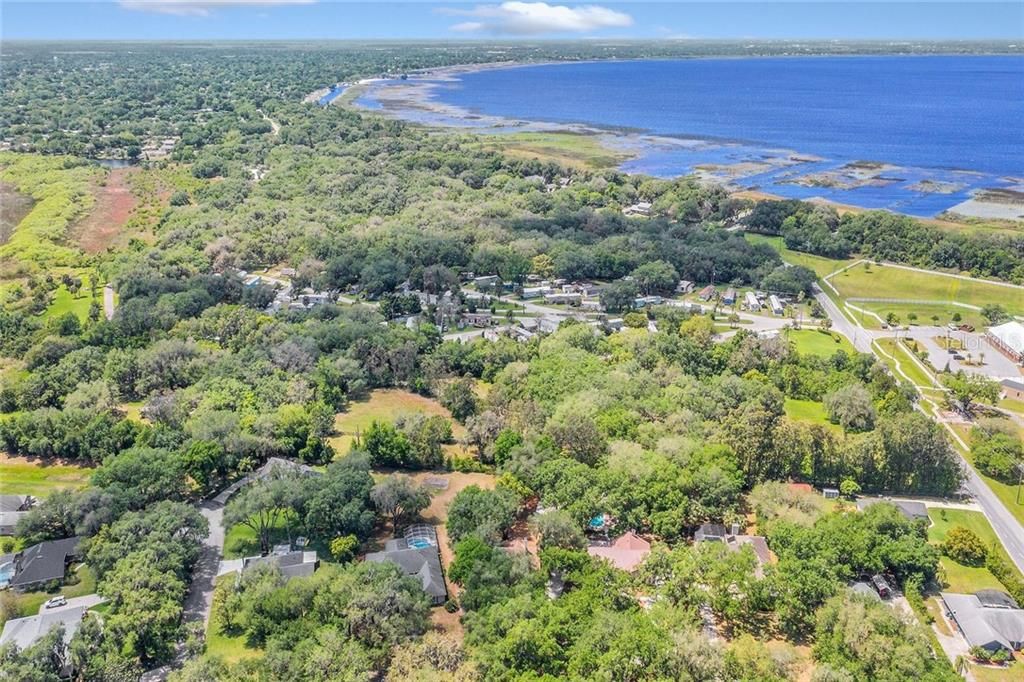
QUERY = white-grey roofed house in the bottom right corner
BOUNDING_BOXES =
[941,590,1024,651]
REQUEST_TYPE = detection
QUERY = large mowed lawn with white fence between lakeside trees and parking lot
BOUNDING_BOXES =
[829,264,1024,314]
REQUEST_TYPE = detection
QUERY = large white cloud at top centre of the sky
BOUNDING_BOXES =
[438,2,633,36]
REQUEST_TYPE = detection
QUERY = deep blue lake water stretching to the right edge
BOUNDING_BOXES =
[361,56,1024,215]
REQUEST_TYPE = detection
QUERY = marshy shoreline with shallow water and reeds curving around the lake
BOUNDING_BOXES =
[344,54,1024,223]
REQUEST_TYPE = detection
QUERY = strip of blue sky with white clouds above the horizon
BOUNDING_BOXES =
[0,0,1024,40]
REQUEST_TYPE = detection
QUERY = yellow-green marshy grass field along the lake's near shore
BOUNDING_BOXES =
[473,132,629,168]
